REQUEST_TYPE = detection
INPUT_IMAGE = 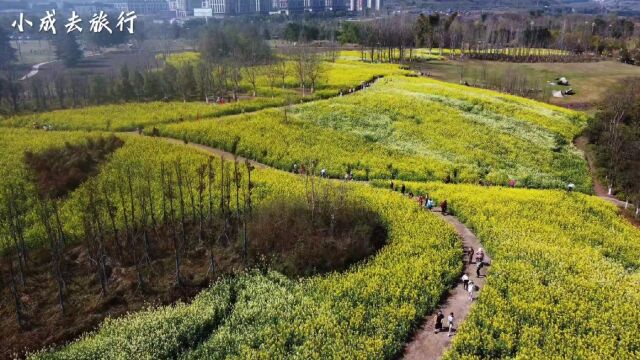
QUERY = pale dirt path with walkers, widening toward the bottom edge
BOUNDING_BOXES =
[402,212,491,360]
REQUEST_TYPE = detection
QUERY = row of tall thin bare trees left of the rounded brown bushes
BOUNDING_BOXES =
[0,149,253,327]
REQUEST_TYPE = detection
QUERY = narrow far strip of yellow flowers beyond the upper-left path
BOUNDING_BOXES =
[0,57,406,131]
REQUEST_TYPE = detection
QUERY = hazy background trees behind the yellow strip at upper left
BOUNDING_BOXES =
[0,23,335,114]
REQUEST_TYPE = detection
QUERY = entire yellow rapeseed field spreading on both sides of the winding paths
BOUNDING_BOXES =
[0,57,640,359]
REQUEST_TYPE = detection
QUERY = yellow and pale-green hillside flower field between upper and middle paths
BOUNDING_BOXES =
[160,76,591,191]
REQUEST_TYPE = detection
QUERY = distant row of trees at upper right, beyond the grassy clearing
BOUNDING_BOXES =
[339,13,640,61]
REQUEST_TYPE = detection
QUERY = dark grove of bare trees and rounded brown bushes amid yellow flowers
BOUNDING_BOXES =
[0,137,370,328]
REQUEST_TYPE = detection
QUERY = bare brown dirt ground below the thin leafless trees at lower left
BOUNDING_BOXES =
[0,235,241,359]
